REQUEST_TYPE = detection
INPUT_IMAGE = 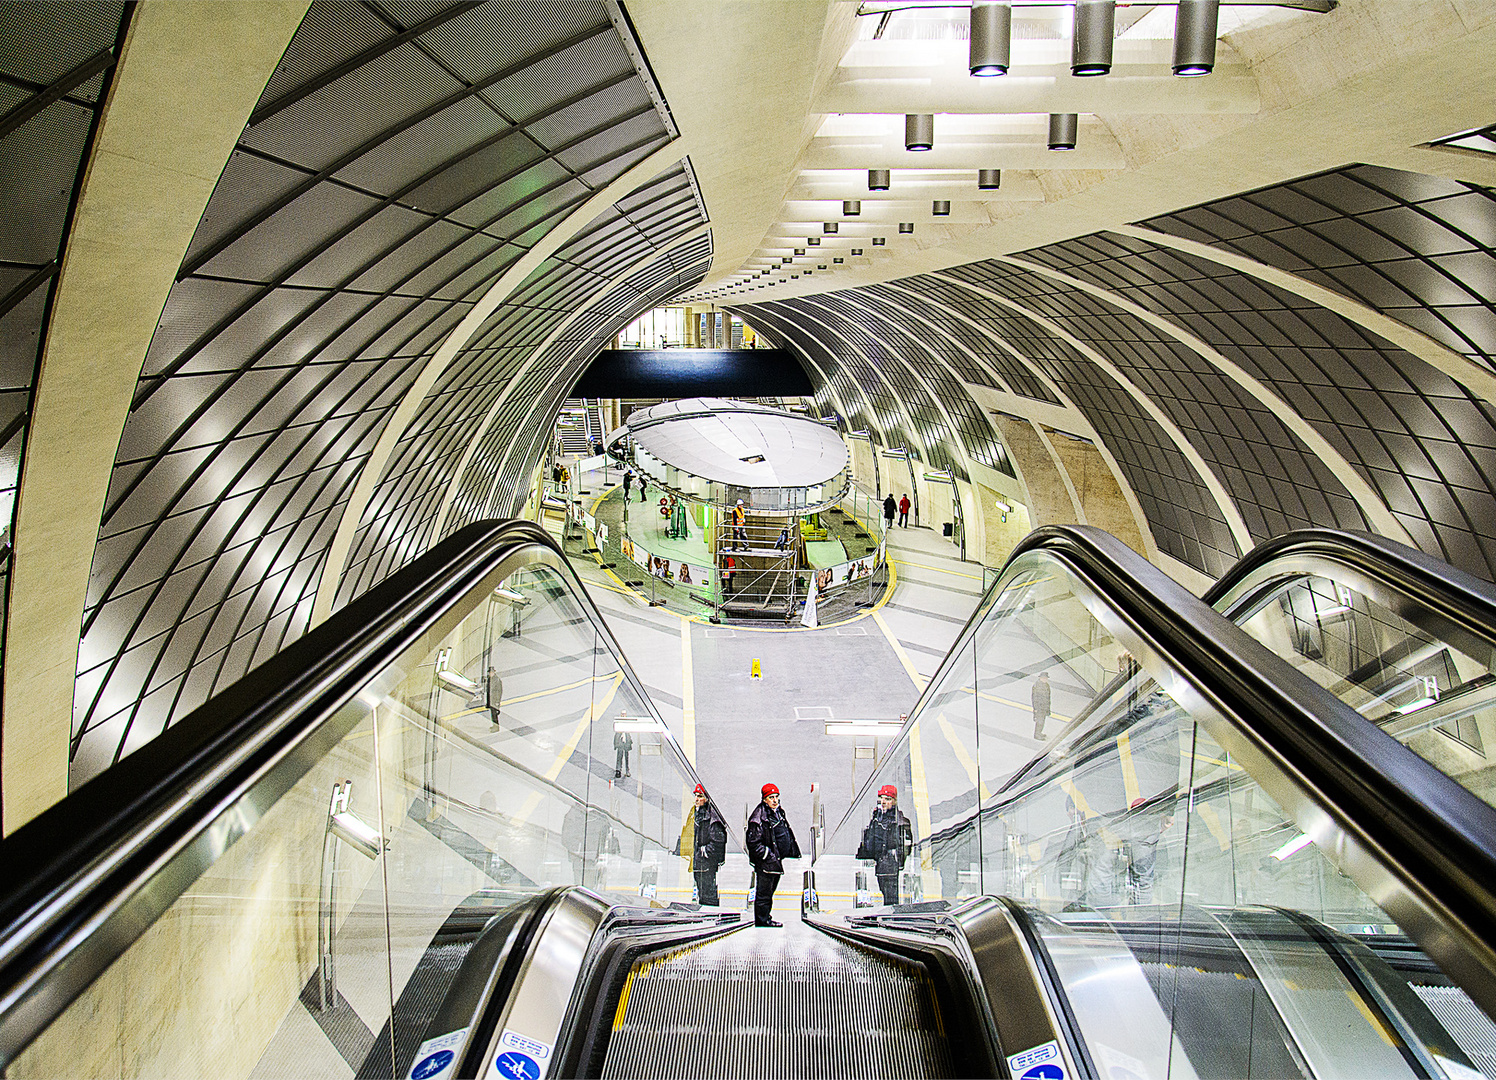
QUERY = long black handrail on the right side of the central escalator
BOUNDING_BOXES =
[833,525,1496,1013]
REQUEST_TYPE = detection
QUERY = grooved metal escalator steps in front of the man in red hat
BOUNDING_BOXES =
[603,930,951,1079]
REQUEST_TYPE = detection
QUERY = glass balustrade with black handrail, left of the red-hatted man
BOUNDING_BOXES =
[0,522,730,1077]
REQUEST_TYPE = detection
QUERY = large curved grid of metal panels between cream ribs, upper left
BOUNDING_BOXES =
[72,0,672,781]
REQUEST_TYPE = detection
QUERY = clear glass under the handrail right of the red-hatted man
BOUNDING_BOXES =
[815,552,1490,1077]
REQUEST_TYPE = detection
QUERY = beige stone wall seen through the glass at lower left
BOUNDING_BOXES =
[6,720,389,1080]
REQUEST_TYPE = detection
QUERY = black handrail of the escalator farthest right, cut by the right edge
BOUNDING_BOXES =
[1201,528,1496,646]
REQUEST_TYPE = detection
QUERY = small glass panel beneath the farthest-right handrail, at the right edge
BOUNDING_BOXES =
[1237,576,1496,803]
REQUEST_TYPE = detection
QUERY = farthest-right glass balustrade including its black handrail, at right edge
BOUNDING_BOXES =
[1204,530,1496,803]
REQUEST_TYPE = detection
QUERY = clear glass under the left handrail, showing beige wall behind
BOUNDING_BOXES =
[7,549,712,1077]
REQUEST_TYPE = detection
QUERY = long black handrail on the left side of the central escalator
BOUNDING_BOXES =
[0,519,715,1067]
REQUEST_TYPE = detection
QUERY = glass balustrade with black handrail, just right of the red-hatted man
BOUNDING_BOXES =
[814,527,1496,1077]
